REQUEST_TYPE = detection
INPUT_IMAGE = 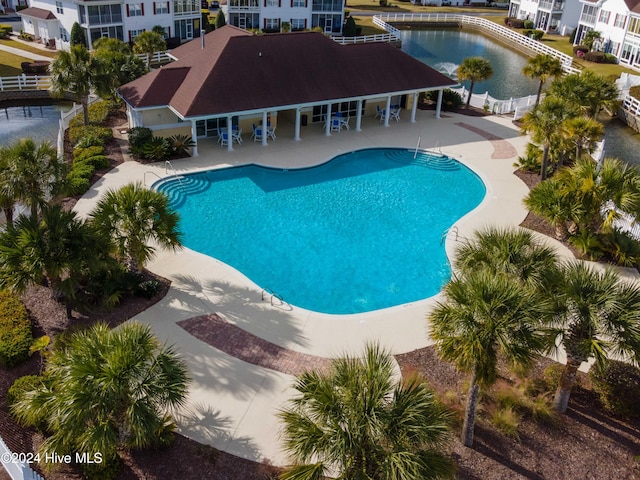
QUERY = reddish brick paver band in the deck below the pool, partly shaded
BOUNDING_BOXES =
[177,313,331,376]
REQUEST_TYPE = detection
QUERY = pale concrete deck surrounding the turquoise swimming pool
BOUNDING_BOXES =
[75,111,570,465]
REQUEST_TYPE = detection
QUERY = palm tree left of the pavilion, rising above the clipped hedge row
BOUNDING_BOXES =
[51,44,101,125]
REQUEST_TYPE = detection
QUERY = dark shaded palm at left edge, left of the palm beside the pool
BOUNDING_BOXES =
[0,205,101,316]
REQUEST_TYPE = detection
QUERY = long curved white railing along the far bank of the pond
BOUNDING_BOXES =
[373,13,580,73]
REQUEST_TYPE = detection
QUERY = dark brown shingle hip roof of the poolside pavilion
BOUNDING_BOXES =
[120,26,456,117]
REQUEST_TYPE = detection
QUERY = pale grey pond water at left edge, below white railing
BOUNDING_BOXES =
[0,103,71,145]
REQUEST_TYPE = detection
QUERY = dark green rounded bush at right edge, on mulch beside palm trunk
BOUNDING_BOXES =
[589,360,640,418]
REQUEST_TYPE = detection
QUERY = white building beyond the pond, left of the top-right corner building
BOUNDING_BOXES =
[509,0,581,35]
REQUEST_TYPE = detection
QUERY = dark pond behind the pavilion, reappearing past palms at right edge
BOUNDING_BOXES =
[402,29,640,166]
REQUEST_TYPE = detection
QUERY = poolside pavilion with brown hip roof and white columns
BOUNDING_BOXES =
[119,25,457,155]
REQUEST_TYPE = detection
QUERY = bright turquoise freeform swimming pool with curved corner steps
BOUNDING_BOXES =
[157,149,486,314]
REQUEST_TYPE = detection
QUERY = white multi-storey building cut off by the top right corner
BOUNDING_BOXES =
[574,0,640,70]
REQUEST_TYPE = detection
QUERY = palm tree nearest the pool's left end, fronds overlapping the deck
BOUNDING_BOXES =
[91,182,182,271]
